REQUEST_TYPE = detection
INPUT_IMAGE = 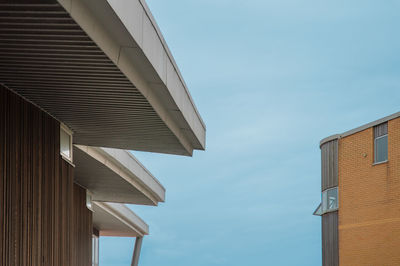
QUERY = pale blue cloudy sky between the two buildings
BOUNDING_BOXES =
[100,0,400,266]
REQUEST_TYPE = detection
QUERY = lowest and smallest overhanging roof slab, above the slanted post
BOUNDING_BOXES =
[92,201,149,237]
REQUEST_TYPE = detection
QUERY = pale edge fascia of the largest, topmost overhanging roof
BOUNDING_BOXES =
[58,0,206,155]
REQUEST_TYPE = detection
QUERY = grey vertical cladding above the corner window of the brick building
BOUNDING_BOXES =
[321,139,338,191]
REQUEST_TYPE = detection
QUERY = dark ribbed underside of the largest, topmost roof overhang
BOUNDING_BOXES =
[0,0,202,155]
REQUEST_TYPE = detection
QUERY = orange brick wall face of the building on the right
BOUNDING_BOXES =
[339,118,400,266]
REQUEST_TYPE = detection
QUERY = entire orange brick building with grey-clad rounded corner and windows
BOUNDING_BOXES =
[314,113,400,266]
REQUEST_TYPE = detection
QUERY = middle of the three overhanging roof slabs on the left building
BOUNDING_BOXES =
[74,145,165,205]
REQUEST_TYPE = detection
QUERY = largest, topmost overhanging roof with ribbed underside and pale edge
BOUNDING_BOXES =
[0,0,205,155]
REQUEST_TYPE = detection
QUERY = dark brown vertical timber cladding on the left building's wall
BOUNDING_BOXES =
[0,85,92,266]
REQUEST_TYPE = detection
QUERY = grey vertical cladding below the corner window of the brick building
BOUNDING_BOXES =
[322,211,339,266]
